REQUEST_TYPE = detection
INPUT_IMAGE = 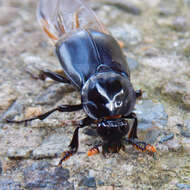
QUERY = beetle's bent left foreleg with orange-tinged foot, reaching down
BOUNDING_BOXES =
[58,117,94,167]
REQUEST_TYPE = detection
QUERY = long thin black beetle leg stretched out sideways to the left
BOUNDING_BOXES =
[7,104,83,123]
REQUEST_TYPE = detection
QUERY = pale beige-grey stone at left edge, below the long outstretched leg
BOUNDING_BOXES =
[0,125,46,159]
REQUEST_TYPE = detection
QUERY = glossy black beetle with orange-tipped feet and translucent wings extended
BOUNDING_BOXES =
[8,0,156,166]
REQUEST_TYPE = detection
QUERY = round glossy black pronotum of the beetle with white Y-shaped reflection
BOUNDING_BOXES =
[81,71,136,119]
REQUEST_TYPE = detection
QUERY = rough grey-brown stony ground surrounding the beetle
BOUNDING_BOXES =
[0,0,190,190]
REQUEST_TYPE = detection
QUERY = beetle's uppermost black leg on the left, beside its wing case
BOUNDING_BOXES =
[39,70,71,84]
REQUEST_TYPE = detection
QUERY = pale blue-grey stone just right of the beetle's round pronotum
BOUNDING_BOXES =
[135,100,168,130]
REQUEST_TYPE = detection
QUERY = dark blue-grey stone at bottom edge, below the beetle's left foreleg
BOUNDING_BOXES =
[23,161,74,190]
